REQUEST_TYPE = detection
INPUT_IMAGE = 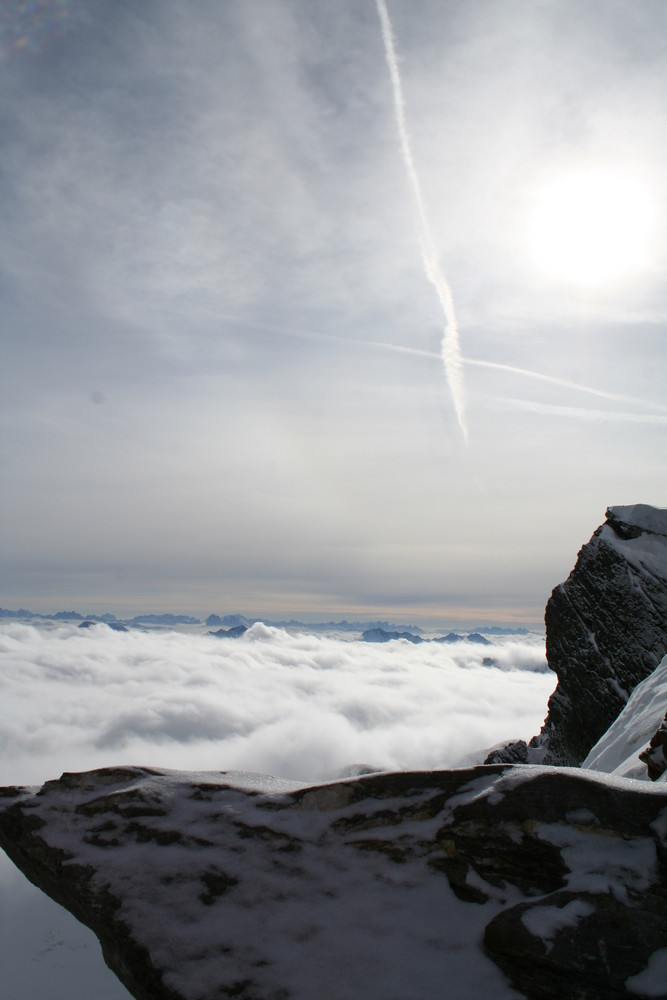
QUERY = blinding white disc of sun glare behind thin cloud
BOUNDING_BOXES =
[529,167,654,287]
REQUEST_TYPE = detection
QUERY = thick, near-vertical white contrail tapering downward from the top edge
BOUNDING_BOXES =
[376,0,468,444]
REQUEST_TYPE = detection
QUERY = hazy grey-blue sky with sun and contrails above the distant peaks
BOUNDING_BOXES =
[0,0,667,624]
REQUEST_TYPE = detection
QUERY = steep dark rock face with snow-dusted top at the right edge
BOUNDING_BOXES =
[529,504,667,765]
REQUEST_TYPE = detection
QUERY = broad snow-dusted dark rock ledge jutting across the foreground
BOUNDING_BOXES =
[0,765,667,1000]
